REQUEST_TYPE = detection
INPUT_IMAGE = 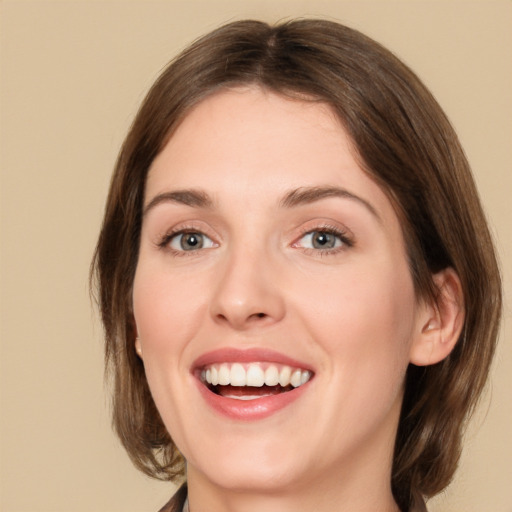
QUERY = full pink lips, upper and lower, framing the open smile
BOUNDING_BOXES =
[193,348,311,421]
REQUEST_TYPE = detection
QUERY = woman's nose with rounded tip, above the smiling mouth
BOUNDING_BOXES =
[211,245,285,331]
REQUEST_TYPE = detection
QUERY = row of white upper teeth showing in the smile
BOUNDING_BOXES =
[201,363,311,388]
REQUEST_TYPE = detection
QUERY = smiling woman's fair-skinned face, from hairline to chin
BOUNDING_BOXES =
[133,88,422,496]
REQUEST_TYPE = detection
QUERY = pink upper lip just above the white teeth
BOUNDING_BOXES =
[192,347,313,372]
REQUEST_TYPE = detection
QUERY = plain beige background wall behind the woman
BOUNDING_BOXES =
[0,0,512,512]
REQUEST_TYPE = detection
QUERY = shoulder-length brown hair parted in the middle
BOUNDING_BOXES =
[92,19,501,510]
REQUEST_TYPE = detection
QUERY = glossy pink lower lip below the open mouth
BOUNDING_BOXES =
[197,380,309,421]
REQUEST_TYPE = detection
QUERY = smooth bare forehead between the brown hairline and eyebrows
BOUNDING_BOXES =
[145,87,390,218]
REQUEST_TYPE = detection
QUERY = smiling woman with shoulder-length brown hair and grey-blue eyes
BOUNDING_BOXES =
[94,20,501,512]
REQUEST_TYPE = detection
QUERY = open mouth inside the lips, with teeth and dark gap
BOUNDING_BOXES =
[200,362,313,400]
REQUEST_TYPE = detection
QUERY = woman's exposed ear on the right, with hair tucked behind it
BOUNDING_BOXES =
[410,268,464,366]
